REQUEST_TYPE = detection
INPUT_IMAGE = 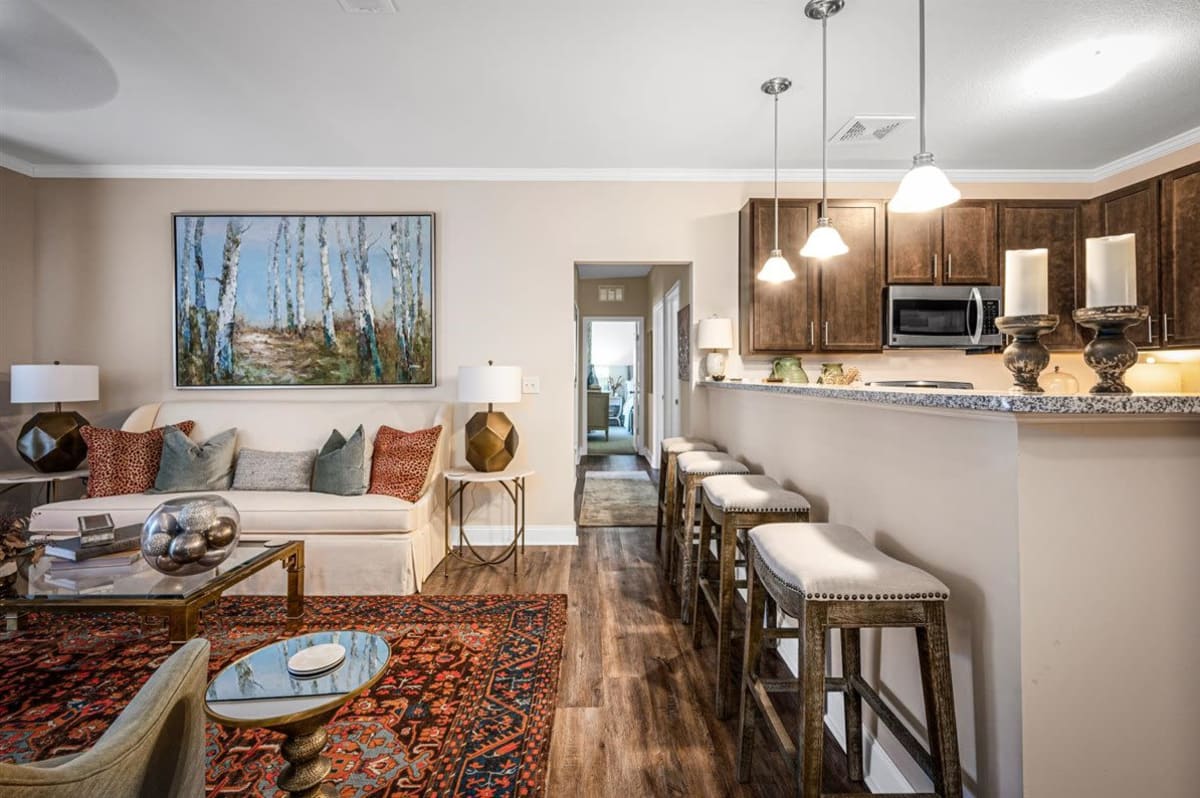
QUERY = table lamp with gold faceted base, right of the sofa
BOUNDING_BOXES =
[458,360,521,473]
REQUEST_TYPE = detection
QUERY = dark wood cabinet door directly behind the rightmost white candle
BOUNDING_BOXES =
[1099,180,1163,347]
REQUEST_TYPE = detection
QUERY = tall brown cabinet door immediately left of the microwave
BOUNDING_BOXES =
[818,199,884,352]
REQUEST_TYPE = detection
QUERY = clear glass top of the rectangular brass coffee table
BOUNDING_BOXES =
[13,541,295,600]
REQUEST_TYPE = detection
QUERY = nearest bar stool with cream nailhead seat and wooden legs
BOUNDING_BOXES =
[738,523,962,798]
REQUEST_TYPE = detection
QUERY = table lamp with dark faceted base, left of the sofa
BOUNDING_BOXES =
[12,360,100,474]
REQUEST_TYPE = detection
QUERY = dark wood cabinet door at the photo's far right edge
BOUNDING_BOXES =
[1161,163,1200,347]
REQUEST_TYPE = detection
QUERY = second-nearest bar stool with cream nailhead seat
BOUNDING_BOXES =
[684,474,810,719]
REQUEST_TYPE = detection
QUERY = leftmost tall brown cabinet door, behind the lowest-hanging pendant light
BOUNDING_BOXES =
[739,199,816,354]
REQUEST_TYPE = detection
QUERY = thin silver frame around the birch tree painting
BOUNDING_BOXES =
[169,211,438,391]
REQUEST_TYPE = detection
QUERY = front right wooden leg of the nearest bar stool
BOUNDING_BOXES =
[917,601,962,798]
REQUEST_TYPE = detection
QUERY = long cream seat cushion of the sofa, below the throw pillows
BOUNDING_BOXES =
[30,491,428,535]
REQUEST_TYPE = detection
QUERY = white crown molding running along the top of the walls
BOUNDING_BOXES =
[0,127,1200,184]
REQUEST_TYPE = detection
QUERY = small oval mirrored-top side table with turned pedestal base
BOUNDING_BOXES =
[204,631,391,797]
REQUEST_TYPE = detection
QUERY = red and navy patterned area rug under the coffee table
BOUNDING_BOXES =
[0,595,566,798]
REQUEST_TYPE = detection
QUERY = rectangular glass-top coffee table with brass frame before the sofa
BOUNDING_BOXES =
[0,540,304,644]
